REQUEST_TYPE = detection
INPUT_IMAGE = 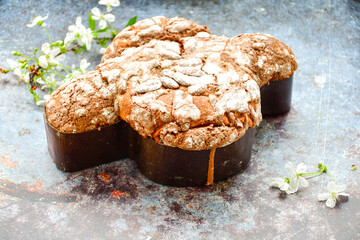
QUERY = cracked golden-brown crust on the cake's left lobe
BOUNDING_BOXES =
[45,70,120,133]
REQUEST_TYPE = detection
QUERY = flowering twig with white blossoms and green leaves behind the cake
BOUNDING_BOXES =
[0,0,136,105]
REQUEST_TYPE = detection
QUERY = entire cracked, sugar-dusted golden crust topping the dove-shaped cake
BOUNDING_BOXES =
[45,17,297,150]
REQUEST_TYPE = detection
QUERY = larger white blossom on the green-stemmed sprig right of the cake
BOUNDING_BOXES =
[285,162,309,194]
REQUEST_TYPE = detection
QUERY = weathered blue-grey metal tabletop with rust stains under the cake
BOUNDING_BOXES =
[0,0,360,240]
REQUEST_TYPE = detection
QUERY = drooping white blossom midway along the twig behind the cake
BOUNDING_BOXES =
[64,17,93,50]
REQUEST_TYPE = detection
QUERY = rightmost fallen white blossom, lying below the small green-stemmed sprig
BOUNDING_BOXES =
[318,181,349,208]
